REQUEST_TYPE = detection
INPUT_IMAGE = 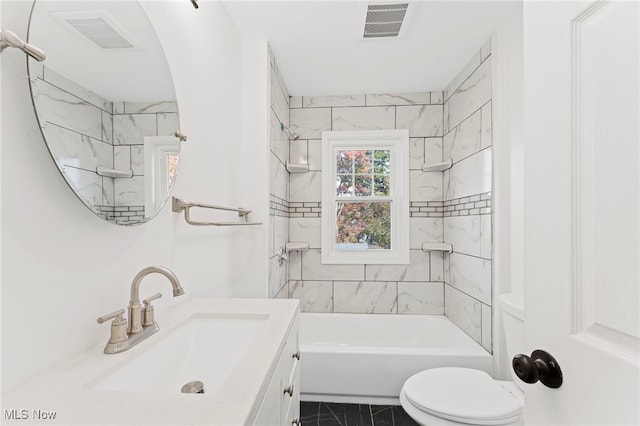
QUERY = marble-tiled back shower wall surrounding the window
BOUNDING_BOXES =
[287,92,445,314]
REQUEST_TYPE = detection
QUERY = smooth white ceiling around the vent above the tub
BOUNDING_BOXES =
[225,0,522,96]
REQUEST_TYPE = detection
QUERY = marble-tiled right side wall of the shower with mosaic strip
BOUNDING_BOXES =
[442,41,493,352]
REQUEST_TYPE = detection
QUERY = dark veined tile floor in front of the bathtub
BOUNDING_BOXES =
[300,401,417,426]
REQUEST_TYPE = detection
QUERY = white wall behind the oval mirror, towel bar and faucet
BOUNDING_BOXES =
[0,1,254,392]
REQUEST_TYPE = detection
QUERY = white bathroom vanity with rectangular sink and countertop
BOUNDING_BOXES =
[2,298,300,426]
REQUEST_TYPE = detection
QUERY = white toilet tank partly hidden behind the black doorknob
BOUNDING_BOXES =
[500,293,526,388]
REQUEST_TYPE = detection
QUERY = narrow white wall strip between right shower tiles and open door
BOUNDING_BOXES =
[493,9,524,380]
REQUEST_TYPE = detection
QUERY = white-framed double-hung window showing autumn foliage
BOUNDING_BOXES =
[322,130,409,264]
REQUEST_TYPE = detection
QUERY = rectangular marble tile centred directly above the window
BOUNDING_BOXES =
[331,106,396,130]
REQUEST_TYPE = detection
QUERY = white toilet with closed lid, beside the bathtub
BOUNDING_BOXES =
[400,293,524,426]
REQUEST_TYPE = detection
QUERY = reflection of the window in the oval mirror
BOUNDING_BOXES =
[144,136,180,218]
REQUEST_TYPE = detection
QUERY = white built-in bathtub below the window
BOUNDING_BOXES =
[299,313,493,404]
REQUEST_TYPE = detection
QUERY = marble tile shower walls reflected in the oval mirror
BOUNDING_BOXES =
[31,65,179,224]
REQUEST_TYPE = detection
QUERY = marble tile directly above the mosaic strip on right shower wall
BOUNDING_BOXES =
[444,148,491,200]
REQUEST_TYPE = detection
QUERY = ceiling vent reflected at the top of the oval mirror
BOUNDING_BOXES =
[52,10,136,50]
